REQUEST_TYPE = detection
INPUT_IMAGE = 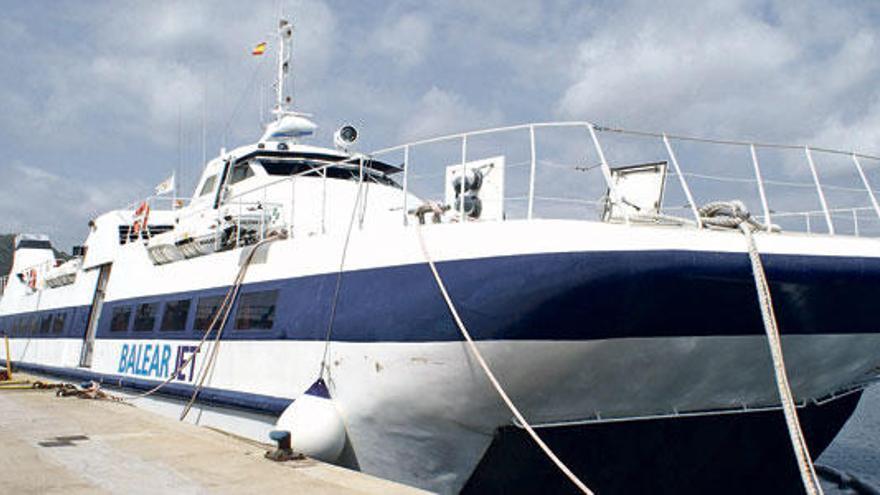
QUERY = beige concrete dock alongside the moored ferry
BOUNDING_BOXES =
[0,375,425,494]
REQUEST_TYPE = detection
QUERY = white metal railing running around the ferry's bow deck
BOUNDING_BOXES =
[108,121,880,243]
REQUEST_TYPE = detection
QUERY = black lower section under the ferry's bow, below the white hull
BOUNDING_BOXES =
[463,392,861,495]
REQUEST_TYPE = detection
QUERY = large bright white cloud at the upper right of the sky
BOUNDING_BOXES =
[557,1,880,146]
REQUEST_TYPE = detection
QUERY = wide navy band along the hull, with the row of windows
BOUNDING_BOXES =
[0,251,880,342]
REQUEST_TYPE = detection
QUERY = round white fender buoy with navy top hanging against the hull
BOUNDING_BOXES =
[275,378,346,463]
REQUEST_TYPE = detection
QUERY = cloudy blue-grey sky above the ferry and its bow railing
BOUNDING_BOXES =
[0,0,880,249]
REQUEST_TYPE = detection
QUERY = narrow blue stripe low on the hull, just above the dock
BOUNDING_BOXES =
[0,360,293,416]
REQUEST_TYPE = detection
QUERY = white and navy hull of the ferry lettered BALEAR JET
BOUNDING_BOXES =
[0,221,880,492]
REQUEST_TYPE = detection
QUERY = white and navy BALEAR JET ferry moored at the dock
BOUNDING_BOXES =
[0,16,880,493]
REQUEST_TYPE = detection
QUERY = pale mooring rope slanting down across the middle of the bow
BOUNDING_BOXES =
[416,223,593,495]
